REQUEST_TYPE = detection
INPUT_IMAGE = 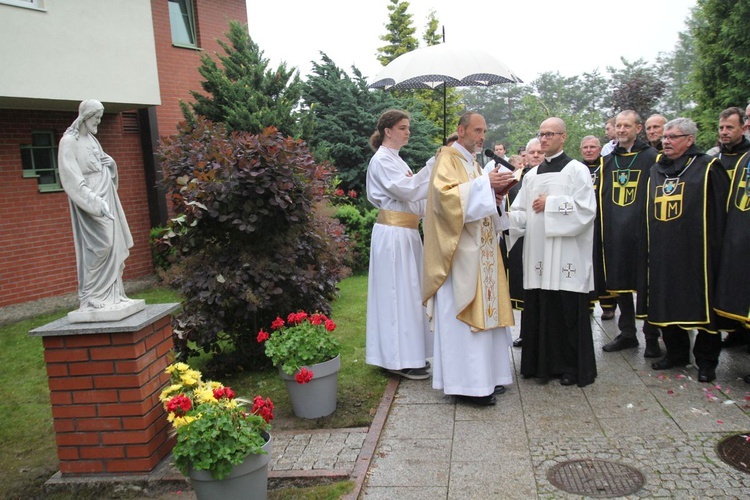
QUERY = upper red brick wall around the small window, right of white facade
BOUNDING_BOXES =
[151,0,247,136]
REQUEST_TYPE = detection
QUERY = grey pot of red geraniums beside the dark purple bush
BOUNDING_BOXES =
[257,311,341,418]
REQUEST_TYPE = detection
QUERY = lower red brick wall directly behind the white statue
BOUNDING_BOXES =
[0,110,153,307]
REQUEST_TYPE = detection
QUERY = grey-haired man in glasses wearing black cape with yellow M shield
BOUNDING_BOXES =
[638,118,729,382]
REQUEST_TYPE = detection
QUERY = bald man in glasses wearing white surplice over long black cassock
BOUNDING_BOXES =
[509,118,596,387]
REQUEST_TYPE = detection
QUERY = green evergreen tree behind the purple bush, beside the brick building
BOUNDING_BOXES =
[183,21,301,136]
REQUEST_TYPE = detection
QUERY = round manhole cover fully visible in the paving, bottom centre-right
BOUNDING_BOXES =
[547,460,644,498]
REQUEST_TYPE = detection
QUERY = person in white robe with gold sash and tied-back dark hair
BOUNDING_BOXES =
[365,109,432,380]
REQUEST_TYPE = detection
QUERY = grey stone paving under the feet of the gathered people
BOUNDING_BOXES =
[361,313,750,499]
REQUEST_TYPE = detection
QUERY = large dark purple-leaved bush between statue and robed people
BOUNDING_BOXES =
[160,117,350,365]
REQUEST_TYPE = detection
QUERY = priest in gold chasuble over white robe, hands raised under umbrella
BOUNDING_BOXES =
[423,113,513,406]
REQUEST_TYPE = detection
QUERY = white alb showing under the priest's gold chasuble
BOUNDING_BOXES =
[432,143,513,396]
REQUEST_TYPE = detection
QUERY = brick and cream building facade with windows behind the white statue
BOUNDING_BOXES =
[0,0,253,307]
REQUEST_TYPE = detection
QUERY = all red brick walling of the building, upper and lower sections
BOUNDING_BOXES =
[0,0,253,307]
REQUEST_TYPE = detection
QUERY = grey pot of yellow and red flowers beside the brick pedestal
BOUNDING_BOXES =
[160,363,273,500]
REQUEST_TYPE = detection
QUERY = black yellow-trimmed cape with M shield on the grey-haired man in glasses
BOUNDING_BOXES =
[638,146,729,332]
